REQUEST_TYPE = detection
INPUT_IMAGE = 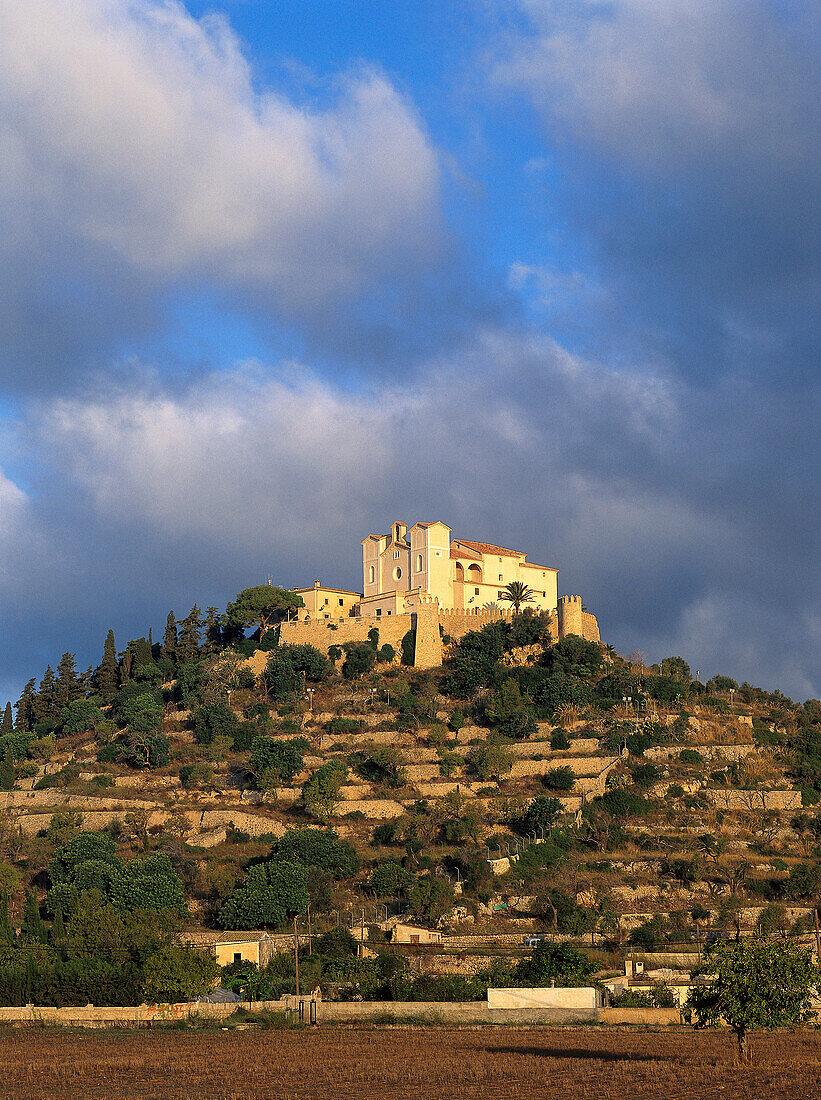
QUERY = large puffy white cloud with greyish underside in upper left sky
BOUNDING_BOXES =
[0,0,438,312]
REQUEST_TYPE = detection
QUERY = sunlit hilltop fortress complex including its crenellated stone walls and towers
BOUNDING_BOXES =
[281,521,599,669]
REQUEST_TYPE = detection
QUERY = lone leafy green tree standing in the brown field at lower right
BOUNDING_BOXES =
[687,939,821,1062]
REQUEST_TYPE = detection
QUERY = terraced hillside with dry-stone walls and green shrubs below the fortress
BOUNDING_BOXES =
[0,613,821,1007]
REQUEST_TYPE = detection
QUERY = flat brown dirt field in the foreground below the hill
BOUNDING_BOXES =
[0,1027,821,1100]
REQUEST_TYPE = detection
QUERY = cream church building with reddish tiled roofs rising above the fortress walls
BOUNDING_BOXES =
[359,523,558,618]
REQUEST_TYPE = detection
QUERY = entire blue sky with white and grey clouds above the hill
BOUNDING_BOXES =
[0,0,821,706]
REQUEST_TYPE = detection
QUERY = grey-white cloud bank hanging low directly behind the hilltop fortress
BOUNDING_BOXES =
[6,330,821,697]
